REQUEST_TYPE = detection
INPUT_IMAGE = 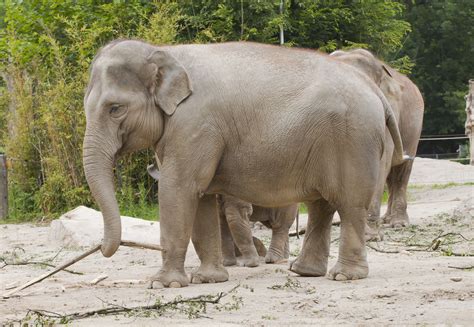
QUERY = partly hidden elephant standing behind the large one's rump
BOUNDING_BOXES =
[331,49,424,240]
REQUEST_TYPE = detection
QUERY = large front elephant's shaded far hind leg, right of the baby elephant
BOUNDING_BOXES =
[290,199,335,276]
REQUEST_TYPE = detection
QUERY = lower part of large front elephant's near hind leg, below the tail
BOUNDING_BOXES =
[329,206,369,280]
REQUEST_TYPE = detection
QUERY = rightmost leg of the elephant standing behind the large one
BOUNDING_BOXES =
[384,161,413,227]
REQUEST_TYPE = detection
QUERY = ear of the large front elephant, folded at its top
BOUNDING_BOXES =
[148,50,192,115]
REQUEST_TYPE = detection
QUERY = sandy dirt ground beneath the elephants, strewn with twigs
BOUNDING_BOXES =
[0,159,474,326]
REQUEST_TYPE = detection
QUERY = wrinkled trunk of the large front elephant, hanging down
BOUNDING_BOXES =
[83,131,122,257]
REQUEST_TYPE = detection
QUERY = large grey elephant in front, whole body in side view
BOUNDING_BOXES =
[83,40,404,287]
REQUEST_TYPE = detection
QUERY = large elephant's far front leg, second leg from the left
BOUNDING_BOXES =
[191,195,229,284]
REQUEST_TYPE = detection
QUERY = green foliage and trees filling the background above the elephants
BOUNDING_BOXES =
[0,0,474,220]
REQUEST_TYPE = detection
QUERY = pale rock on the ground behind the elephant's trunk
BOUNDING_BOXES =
[48,206,160,247]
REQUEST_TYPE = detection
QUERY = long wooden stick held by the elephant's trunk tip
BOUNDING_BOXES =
[2,241,163,299]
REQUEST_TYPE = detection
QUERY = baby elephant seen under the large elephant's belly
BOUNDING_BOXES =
[218,195,298,267]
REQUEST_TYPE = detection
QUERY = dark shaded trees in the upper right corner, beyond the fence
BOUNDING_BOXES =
[401,0,474,152]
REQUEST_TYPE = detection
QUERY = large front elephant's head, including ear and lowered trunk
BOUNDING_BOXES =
[83,41,191,257]
